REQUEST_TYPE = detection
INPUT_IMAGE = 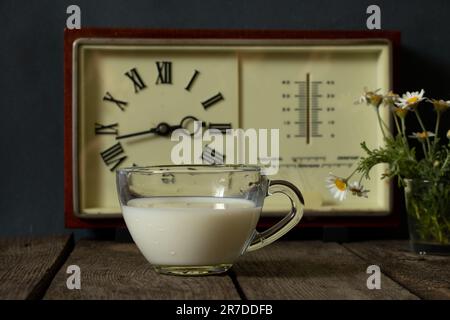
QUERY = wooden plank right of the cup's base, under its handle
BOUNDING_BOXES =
[233,241,417,299]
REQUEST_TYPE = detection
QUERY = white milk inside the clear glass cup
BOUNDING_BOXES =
[122,197,261,266]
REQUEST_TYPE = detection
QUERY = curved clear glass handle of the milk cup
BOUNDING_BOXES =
[246,180,305,252]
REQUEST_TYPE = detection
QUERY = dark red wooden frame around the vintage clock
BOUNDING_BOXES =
[64,29,401,228]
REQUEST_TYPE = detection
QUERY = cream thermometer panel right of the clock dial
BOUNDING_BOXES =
[240,45,391,216]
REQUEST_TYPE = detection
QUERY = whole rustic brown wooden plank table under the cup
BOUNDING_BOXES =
[0,236,450,300]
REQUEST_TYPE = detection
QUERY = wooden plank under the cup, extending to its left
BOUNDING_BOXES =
[44,240,240,300]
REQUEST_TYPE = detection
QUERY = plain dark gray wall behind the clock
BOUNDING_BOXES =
[0,0,450,236]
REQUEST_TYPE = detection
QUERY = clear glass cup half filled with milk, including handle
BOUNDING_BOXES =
[116,165,304,275]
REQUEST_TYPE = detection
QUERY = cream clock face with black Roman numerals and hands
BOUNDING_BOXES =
[78,46,238,214]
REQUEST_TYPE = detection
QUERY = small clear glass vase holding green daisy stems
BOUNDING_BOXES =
[405,179,450,255]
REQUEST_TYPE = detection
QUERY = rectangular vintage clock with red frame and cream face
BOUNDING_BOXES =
[65,29,399,227]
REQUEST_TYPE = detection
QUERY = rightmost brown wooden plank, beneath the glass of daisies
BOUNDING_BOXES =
[345,241,450,299]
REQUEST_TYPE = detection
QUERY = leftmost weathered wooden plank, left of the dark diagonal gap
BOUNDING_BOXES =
[0,235,73,299]
